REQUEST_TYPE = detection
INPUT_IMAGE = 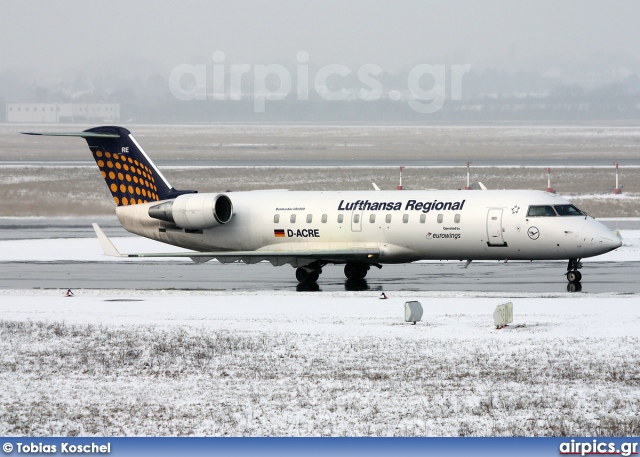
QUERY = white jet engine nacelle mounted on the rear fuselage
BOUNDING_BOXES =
[149,194,233,230]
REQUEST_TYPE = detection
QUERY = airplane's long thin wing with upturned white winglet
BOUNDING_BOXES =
[91,223,380,266]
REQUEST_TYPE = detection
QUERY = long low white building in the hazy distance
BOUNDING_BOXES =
[6,103,120,123]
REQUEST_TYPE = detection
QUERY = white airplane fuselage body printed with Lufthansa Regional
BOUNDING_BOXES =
[116,190,621,264]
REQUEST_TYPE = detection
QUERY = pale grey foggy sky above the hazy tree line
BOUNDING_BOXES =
[0,0,640,76]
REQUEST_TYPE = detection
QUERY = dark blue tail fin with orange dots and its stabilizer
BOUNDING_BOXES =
[26,126,197,206]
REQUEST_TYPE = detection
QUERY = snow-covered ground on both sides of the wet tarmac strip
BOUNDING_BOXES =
[0,231,640,436]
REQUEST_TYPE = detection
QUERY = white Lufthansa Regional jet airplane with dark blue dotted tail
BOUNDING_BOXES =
[25,126,622,284]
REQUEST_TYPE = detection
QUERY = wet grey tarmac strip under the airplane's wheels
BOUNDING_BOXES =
[0,262,640,293]
